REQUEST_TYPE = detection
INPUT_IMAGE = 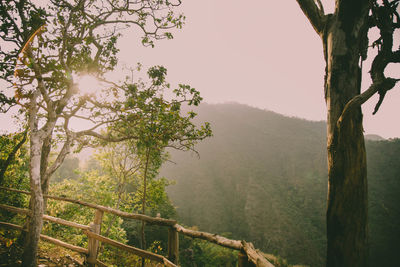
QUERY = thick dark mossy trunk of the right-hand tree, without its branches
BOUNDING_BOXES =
[323,9,368,267]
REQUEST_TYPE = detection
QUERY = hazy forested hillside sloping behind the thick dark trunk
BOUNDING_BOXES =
[162,104,400,266]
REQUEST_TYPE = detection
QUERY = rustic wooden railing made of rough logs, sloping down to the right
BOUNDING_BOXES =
[0,187,273,267]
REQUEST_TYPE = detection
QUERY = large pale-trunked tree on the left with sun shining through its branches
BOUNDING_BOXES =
[0,0,205,266]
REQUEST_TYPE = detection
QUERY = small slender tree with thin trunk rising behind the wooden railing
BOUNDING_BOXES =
[112,66,211,266]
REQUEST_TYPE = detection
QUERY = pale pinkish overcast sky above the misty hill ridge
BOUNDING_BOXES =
[0,0,400,138]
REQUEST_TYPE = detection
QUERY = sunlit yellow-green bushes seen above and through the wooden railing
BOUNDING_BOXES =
[44,142,179,266]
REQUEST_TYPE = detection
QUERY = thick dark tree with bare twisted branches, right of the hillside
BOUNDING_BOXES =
[297,0,400,267]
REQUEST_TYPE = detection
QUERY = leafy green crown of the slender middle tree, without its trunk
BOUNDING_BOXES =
[115,66,211,154]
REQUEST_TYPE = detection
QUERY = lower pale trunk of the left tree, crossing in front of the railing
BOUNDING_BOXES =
[22,131,43,267]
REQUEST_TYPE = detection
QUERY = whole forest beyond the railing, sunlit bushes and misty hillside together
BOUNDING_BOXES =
[0,103,400,267]
